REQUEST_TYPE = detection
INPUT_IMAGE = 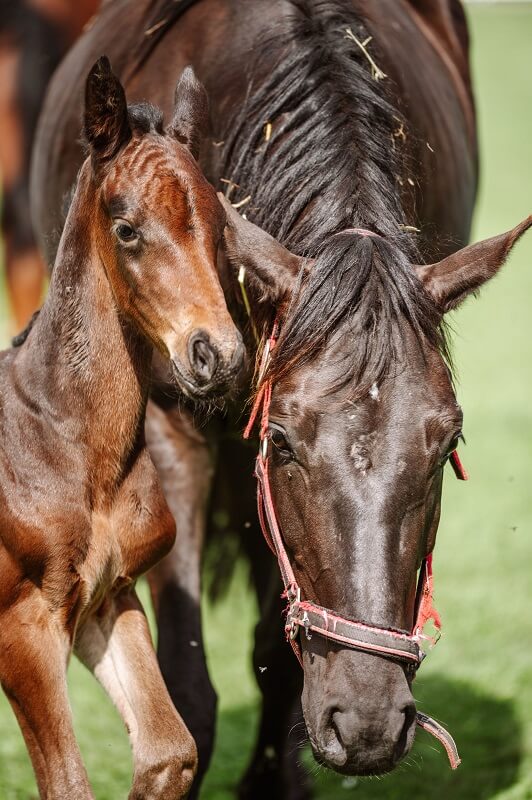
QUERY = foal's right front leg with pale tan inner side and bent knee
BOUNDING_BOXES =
[75,589,197,800]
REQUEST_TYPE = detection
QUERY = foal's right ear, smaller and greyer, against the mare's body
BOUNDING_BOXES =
[168,67,209,159]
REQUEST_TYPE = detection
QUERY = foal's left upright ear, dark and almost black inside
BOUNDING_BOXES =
[84,56,131,166]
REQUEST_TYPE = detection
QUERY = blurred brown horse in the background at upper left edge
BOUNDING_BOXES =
[0,0,100,327]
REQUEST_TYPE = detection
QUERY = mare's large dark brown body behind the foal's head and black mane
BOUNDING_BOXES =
[32,0,477,268]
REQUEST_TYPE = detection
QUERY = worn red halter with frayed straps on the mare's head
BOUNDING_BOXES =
[244,310,468,769]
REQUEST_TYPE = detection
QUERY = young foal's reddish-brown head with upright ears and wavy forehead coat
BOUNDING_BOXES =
[84,57,244,398]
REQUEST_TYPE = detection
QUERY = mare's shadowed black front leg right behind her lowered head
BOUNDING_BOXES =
[216,439,310,800]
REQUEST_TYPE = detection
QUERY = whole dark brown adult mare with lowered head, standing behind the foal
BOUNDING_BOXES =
[33,0,529,800]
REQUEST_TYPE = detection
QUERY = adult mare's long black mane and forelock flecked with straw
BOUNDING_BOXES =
[222,0,448,390]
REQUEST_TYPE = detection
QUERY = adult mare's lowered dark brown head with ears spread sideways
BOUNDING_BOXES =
[226,198,532,774]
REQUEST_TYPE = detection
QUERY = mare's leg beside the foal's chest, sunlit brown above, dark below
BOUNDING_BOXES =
[146,403,216,798]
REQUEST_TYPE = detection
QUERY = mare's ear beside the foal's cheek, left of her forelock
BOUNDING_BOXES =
[218,192,305,305]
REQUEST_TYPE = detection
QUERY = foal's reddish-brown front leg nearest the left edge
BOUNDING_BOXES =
[0,590,93,800]
